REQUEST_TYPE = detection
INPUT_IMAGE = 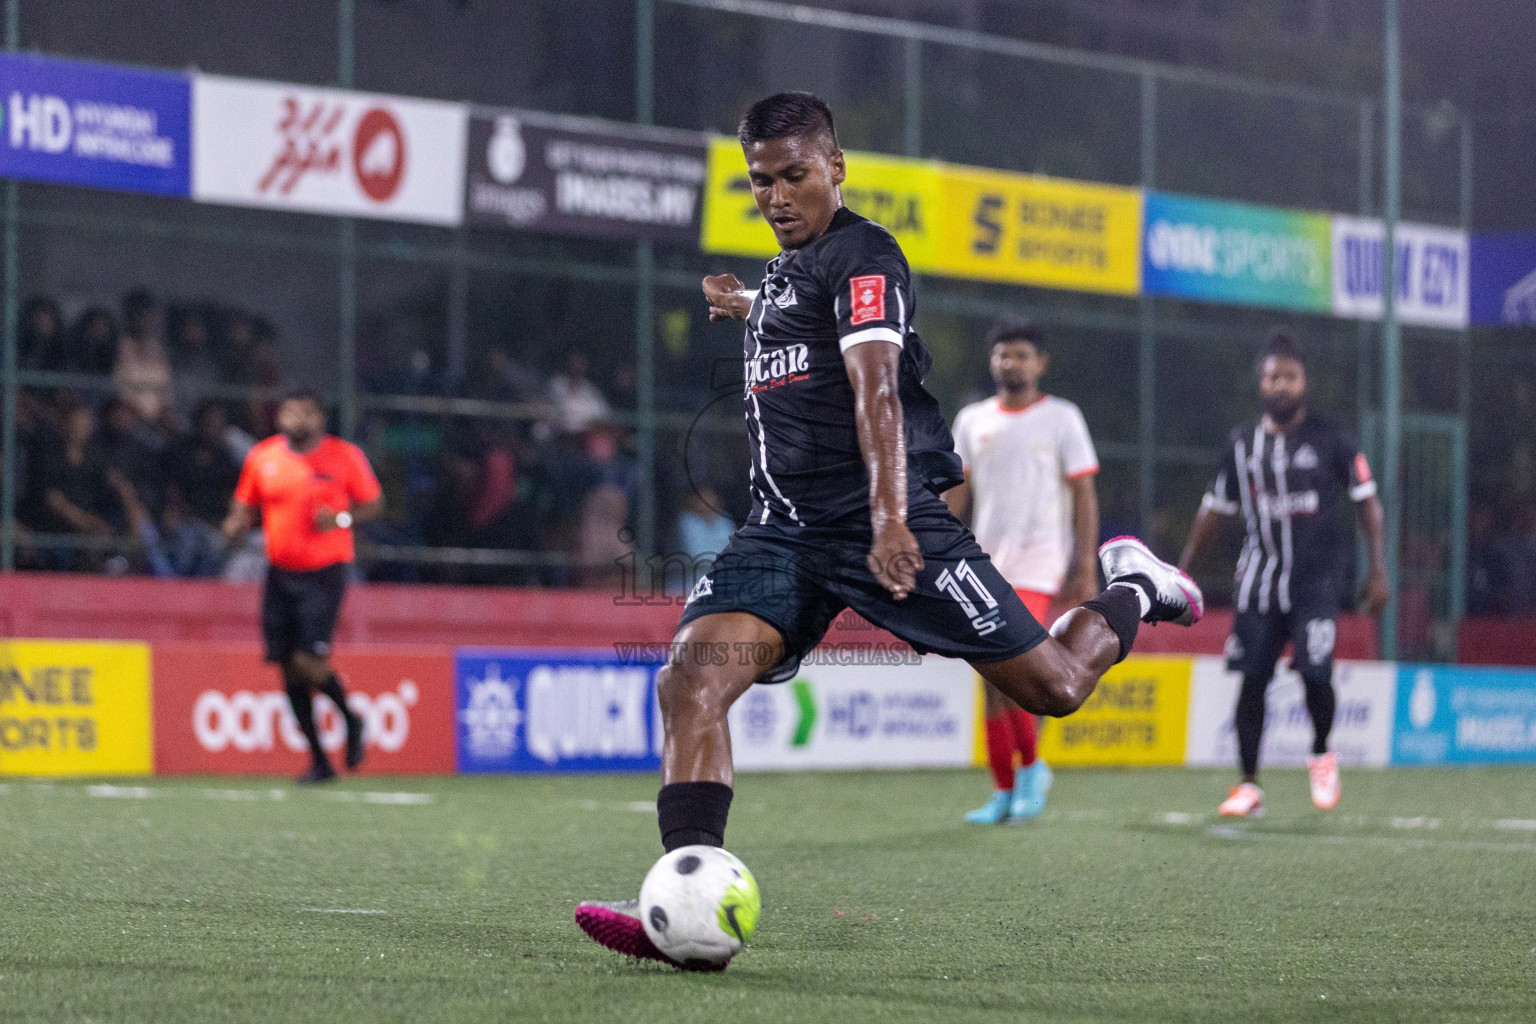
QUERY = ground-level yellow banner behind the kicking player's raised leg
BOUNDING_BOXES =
[1040,656,1190,765]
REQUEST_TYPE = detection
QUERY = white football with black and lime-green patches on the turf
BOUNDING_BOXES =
[641,846,762,964]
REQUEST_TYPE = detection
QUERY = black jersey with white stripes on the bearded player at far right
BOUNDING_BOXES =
[1204,413,1376,613]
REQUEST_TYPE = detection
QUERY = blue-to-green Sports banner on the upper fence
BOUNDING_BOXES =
[1141,192,1333,313]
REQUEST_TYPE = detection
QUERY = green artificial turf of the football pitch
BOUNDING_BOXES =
[0,769,1536,1024]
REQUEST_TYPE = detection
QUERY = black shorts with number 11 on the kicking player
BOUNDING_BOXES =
[677,499,1048,672]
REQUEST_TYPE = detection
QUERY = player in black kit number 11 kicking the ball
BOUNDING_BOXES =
[576,92,1204,963]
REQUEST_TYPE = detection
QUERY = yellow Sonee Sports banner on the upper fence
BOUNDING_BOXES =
[928,166,1141,295]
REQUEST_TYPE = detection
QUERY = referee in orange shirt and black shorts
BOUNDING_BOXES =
[224,390,384,783]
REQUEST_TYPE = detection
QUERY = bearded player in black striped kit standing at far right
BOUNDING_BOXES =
[1178,329,1387,817]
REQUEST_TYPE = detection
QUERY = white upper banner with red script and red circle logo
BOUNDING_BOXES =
[192,75,468,226]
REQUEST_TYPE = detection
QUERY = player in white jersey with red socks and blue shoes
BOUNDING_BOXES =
[945,324,1098,824]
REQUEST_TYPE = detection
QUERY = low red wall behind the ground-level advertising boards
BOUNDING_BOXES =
[0,573,1382,665]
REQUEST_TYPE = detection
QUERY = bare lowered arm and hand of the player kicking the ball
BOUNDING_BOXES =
[843,341,923,600]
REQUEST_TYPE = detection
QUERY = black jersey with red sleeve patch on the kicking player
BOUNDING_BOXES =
[745,209,965,528]
